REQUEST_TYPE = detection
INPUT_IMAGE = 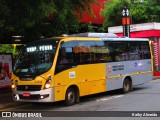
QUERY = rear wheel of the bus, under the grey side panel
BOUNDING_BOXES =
[122,78,132,93]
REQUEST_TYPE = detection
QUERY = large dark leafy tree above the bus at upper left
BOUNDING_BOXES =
[0,0,95,41]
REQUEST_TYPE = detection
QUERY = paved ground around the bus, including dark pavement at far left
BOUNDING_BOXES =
[0,79,160,120]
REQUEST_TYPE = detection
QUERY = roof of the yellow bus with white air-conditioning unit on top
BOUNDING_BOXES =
[25,33,149,45]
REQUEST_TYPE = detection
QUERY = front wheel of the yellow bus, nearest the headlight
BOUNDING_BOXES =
[65,88,76,106]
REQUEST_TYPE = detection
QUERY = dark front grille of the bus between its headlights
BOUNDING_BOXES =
[17,85,42,91]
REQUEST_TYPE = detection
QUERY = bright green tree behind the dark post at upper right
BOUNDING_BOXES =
[101,0,160,29]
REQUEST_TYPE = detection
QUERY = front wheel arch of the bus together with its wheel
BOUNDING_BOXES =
[65,85,79,106]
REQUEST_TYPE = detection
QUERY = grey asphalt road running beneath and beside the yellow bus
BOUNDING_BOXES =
[0,79,160,120]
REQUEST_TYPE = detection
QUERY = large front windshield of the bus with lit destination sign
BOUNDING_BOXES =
[13,40,58,78]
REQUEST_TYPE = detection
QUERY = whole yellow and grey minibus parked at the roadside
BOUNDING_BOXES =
[12,33,153,105]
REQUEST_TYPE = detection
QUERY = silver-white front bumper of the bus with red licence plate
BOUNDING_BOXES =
[12,88,54,102]
